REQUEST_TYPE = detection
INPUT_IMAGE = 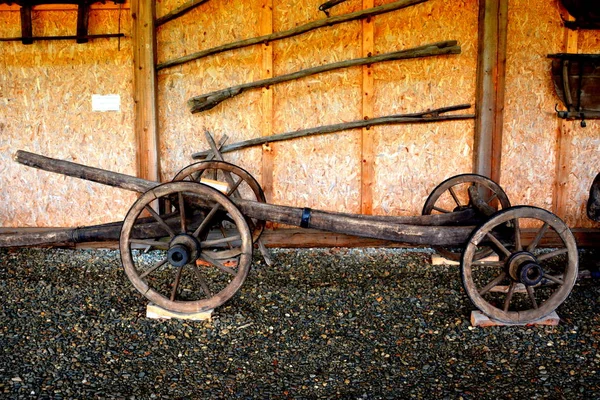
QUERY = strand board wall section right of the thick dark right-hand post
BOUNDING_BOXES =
[501,0,600,227]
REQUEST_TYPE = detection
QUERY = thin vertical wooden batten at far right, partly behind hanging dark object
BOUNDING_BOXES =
[552,10,579,219]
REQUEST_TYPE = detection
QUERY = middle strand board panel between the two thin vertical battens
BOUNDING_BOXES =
[272,0,362,212]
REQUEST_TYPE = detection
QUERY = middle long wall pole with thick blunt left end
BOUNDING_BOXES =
[188,40,461,113]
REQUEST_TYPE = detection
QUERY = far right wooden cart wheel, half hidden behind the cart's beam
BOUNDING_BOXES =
[422,174,510,261]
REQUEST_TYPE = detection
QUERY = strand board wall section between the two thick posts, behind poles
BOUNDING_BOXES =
[157,0,478,222]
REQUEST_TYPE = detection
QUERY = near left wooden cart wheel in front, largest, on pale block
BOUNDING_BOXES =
[120,182,253,313]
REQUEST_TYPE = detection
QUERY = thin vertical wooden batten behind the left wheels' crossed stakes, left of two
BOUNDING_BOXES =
[260,0,277,206]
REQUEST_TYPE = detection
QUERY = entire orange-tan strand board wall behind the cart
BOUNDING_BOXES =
[0,0,600,231]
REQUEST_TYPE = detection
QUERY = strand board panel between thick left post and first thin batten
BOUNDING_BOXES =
[157,0,263,181]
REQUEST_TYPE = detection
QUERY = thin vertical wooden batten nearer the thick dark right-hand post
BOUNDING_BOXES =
[360,0,375,214]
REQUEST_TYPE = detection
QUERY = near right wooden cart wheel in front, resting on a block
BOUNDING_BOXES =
[461,206,578,323]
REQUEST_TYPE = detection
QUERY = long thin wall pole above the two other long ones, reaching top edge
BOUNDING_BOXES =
[156,0,429,71]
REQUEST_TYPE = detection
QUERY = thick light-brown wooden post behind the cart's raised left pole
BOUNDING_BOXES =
[131,0,160,181]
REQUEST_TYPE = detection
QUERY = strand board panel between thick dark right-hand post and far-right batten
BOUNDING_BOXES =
[500,0,564,209]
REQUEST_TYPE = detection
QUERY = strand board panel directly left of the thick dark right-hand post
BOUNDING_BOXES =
[373,1,478,215]
